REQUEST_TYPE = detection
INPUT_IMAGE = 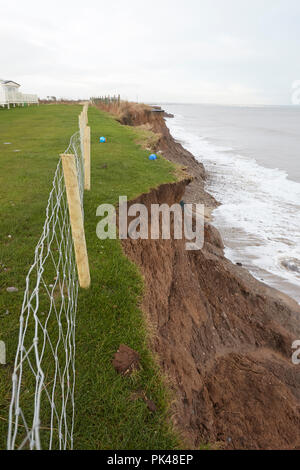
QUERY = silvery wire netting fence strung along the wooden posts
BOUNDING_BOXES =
[7,131,84,449]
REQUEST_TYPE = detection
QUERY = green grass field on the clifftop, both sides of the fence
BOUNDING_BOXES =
[0,105,179,449]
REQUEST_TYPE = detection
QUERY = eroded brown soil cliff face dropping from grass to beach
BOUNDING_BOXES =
[99,103,300,449]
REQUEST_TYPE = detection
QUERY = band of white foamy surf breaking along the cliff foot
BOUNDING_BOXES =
[167,112,300,302]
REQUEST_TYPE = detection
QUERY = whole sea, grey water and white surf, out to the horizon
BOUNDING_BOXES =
[162,104,300,303]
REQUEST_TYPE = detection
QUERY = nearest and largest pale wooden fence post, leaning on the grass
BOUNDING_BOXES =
[61,154,91,289]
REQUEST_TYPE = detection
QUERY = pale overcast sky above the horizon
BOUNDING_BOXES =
[0,0,300,104]
